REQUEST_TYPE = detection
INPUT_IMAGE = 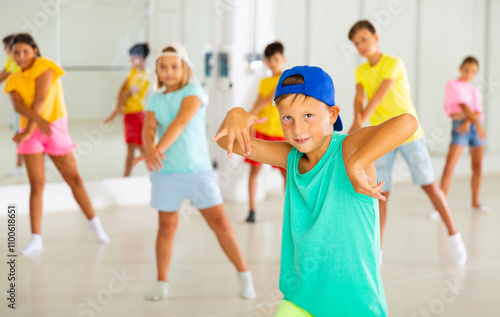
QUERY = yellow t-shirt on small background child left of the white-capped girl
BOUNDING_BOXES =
[123,67,149,113]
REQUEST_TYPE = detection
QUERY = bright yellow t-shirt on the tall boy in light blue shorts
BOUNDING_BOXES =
[355,55,424,143]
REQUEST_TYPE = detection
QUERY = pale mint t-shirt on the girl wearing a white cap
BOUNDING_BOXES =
[146,84,212,173]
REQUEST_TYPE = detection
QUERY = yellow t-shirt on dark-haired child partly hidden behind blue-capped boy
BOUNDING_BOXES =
[255,75,283,138]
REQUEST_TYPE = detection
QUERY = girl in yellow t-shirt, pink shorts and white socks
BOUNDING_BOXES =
[5,33,109,255]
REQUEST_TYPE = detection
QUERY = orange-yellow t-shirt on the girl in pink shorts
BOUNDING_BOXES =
[4,57,67,128]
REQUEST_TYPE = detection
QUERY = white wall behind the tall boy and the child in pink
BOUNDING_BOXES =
[275,0,500,154]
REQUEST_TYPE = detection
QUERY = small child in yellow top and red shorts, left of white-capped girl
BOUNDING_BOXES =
[104,43,149,177]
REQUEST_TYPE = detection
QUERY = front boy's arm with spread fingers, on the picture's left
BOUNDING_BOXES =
[214,108,292,168]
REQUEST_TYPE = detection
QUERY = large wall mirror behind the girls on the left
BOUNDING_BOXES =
[0,0,213,185]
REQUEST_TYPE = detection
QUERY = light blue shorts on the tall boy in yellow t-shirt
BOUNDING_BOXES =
[375,137,436,191]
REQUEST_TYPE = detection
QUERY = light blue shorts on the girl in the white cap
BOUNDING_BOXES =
[150,170,224,212]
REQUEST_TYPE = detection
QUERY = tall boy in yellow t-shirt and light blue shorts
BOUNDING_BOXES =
[349,20,467,266]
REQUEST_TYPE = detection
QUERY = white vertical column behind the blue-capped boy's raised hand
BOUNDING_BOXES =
[207,0,282,202]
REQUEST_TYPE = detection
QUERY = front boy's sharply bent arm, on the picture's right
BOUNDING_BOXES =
[342,114,418,200]
